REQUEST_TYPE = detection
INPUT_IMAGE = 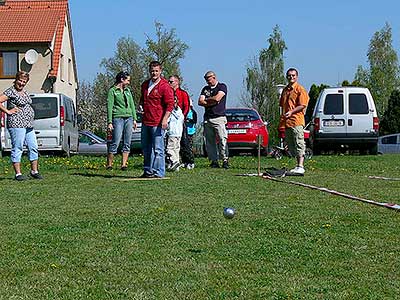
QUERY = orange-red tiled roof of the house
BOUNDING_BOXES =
[0,0,68,77]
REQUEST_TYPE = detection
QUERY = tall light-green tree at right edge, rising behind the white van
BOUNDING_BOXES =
[354,23,400,117]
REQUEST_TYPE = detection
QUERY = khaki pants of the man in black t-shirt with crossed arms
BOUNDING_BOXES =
[204,117,228,161]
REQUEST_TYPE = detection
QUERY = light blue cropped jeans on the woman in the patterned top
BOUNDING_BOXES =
[8,128,39,163]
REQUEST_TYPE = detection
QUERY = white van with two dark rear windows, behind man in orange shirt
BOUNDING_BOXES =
[310,87,379,154]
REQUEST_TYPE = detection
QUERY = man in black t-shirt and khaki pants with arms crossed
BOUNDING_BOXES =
[198,71,229,169]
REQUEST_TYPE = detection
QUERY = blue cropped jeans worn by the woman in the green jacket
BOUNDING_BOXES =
[108,117,133,154]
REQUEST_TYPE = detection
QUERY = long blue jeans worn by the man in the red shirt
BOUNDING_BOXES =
[141,124,165,177]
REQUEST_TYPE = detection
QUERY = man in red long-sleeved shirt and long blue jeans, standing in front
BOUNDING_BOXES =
[140,61,174,178]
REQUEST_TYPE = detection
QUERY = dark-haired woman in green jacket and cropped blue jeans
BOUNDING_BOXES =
[107,71,137,171]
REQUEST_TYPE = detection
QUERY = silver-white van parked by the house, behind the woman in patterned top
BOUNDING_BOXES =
[0,94,79,156]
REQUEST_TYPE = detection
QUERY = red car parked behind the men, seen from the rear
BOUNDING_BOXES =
[226,108,268,154]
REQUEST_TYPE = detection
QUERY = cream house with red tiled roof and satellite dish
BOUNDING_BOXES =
[0,0,78,102]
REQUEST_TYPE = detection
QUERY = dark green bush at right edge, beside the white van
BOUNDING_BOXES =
[380,90,400,135]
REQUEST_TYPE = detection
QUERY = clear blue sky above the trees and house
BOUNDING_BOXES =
[69,0,400,107]
